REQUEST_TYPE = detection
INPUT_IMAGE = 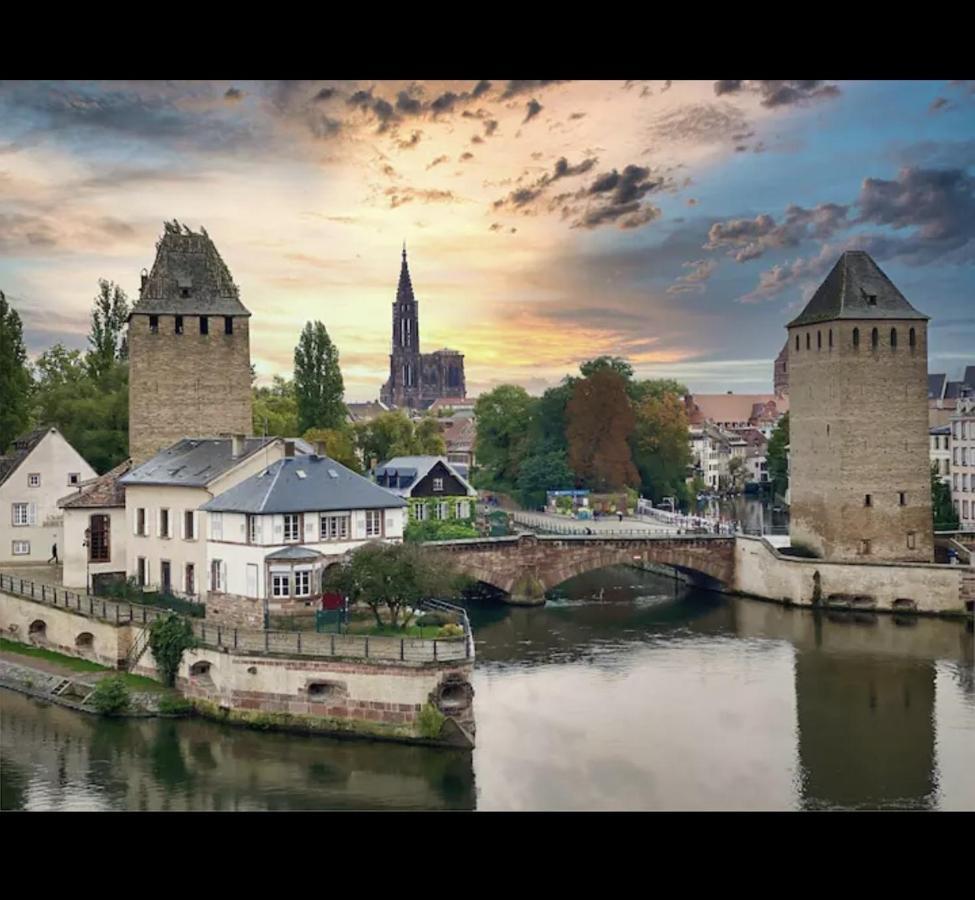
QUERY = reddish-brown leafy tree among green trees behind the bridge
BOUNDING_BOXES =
[566,367,640,491]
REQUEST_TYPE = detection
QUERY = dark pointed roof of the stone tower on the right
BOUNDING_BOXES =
[786,250,928,328]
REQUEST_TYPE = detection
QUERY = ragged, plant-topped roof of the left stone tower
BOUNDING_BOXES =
[132,220,250,316]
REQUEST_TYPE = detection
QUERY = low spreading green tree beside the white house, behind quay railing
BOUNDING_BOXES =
[325,541,460,628]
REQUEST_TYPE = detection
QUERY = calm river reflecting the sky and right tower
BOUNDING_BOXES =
[0,567,975,810]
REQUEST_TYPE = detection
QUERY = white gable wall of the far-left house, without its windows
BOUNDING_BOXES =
[0,428,97,565]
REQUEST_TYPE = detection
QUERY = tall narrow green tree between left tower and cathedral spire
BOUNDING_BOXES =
[295,322,348,433]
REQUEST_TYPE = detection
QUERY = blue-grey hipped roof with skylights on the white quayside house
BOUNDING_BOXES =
[201,455,406,513]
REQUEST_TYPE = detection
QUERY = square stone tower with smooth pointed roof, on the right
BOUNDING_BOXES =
[788,251,934,562]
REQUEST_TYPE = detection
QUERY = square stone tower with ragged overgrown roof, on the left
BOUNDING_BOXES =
[128,222,252,465]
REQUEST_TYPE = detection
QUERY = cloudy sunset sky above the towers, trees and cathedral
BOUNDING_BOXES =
[0,80,975,401]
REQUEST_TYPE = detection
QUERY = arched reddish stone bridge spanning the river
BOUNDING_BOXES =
[427,534,735,605]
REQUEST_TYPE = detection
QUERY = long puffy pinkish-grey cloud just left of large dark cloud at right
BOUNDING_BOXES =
[704,203,850,262]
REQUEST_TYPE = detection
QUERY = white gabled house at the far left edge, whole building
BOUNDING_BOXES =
[0,428,97,565]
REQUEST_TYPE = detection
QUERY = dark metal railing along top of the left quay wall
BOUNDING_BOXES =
[0,574,474,663]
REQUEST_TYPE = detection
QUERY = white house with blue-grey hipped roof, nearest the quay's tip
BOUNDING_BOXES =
[201,454,406,624]
